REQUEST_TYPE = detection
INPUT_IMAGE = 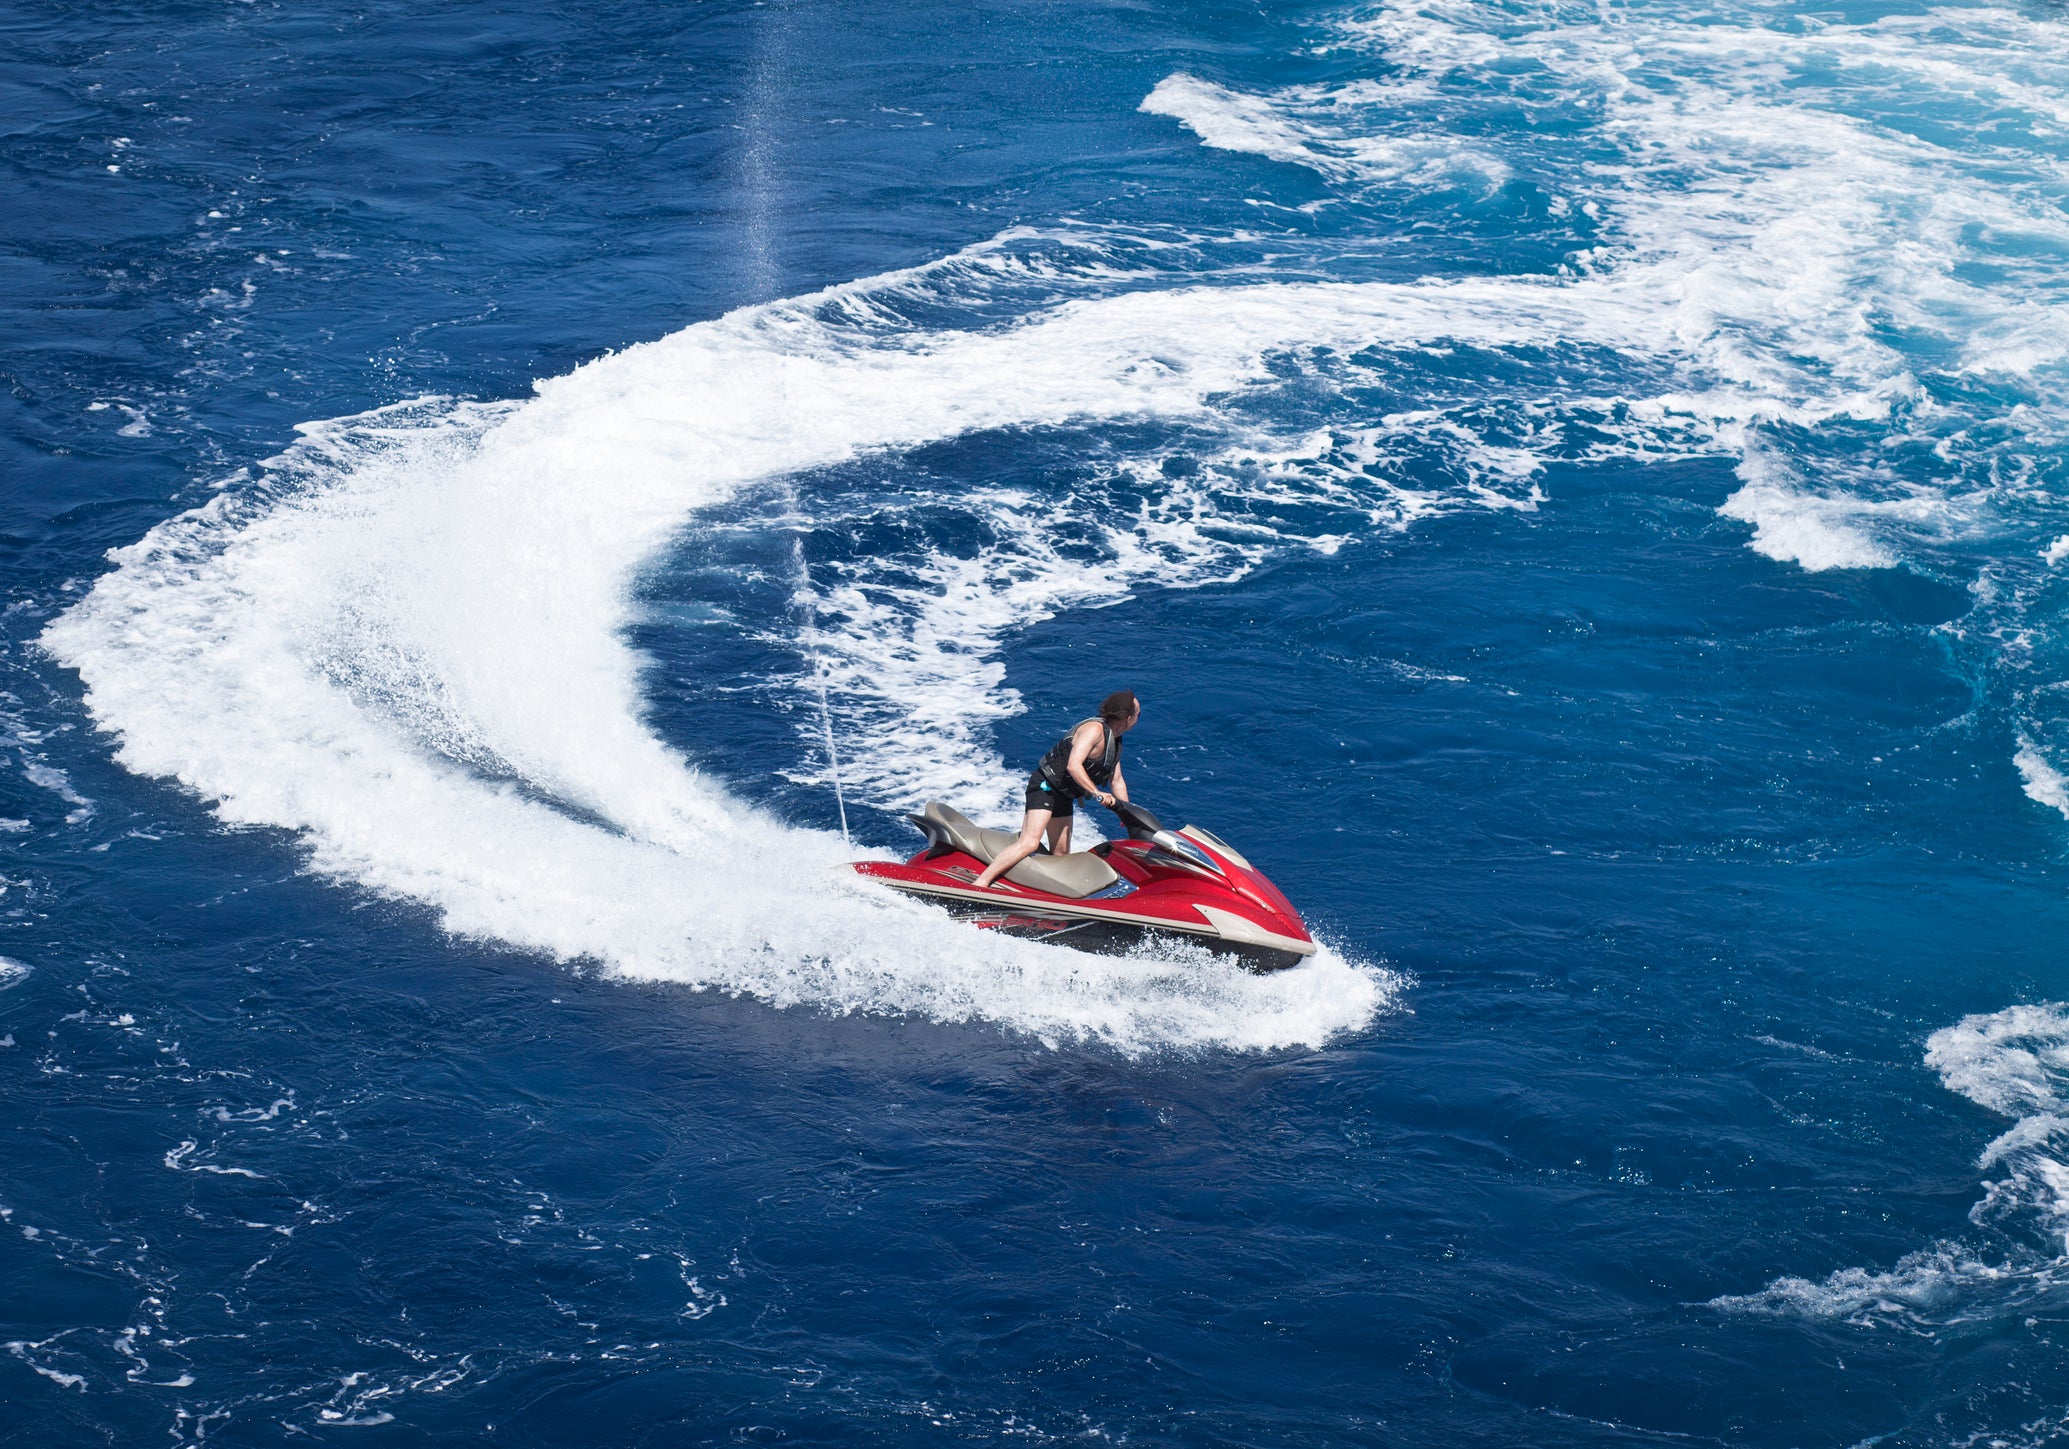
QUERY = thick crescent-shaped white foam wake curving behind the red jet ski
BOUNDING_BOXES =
[56,267,1539,1047]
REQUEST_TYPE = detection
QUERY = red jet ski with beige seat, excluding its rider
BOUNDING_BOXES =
[850,801,1314,971]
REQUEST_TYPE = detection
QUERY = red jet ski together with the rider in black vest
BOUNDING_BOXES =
[852,691,1314,971]
